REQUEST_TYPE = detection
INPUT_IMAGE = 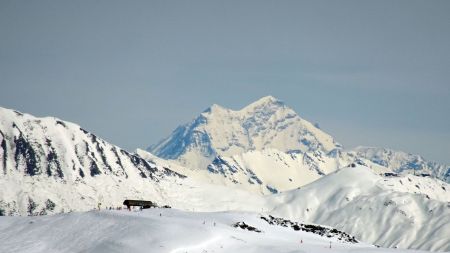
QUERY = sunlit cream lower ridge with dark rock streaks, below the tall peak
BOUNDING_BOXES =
[208,149,339,194]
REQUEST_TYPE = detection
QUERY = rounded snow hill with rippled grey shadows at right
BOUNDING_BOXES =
[271,166,450,251]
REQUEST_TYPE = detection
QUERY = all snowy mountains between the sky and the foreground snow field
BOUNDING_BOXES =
[0,97,450,250]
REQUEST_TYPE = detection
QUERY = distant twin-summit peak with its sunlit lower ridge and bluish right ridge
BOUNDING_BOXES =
[146,96,450,194]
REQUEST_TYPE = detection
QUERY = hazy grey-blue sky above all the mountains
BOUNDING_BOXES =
[0,0,450,164]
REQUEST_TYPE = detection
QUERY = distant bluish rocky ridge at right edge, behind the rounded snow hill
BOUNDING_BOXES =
[349,147,450,182]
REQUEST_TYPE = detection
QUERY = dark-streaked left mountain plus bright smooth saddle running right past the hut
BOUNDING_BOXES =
[0,105,282,216]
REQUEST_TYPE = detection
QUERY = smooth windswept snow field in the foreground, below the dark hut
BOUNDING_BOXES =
[0,209,432,253]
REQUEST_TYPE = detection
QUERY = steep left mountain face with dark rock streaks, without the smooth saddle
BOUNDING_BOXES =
[0,108,185,215]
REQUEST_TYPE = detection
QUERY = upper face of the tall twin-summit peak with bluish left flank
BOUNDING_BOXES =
[148,96,340,168]
